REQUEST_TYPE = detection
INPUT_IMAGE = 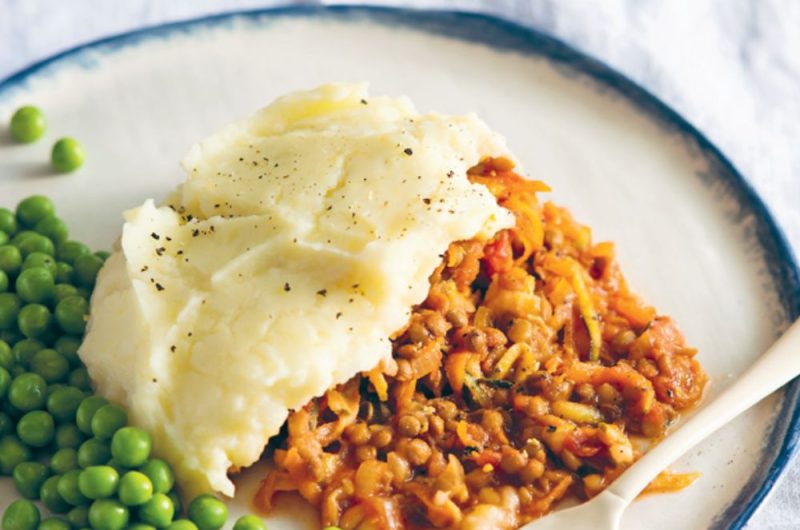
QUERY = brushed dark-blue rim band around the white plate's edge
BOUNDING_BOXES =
[0,6,800,529]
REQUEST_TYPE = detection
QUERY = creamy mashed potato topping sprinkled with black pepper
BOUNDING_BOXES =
[80,85,514,495]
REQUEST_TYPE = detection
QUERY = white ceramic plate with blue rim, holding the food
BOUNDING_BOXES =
[0,7,800,530]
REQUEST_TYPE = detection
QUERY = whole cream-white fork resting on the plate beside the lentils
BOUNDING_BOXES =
[519,320,800,530]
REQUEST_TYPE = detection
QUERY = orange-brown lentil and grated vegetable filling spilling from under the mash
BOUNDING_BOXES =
[255,158,707,530]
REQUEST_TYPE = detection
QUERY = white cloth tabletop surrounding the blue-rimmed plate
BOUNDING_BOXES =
[0,0,800,530]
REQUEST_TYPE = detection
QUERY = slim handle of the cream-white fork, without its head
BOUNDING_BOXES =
[607,319,800,502]
